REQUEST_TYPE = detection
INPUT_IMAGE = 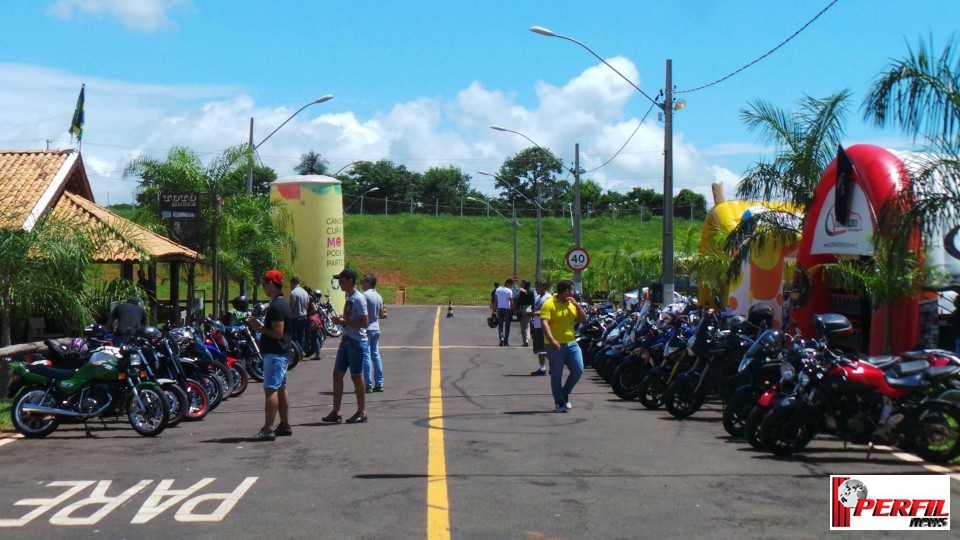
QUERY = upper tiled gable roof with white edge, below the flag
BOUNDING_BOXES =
[0,149,93,228]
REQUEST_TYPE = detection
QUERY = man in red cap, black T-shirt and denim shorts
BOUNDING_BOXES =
[247,270,293,441]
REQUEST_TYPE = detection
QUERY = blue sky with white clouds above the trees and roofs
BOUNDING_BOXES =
[0,0,960,204]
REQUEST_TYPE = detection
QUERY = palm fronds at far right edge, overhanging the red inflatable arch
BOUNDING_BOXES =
[864,39,960,247]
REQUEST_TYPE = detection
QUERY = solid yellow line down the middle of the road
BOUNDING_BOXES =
[427,307,450,539]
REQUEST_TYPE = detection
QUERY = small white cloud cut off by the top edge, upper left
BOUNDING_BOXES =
[48,0,191,32]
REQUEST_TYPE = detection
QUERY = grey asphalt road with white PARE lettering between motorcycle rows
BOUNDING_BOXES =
[0,306,960,539]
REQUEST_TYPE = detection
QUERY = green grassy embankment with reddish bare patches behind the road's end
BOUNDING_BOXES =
[101,214,702,305]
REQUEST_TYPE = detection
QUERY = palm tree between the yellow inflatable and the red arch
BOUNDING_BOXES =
[725,90,850,279]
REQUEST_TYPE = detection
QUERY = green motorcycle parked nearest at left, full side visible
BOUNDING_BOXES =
[7,345,170,438]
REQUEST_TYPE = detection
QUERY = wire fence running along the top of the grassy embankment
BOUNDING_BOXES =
[343,195,709,221]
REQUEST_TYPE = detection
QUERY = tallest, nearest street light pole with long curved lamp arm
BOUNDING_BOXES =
[530,26,684,304]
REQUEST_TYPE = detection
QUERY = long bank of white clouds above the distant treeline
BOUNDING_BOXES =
[0,58,737,207]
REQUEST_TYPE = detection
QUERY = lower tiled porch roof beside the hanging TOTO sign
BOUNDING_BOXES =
[53,192,200,262]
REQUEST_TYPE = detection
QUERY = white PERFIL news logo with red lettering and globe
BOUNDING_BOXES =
[830,474,950,531]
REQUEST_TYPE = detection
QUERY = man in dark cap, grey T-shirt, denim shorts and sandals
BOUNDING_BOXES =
[323,268,370,424]
